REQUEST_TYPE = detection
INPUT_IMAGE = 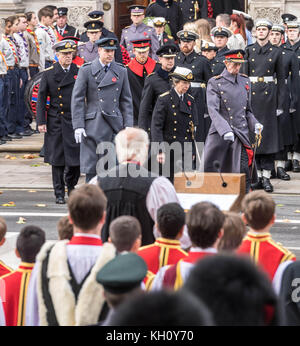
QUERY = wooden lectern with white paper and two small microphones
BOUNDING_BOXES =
[174,172,246,212]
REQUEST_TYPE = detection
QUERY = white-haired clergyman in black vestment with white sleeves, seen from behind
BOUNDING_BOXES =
[91,128,191,248]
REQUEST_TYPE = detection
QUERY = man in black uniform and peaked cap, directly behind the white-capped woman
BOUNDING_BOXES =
[138,44,178,138]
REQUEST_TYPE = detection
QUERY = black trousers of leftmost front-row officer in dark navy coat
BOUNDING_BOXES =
[52,166,80,197]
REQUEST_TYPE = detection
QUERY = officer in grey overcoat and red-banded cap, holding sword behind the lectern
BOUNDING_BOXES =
[203,50,263,191]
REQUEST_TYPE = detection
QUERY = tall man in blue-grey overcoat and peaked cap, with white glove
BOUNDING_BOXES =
[71,38,133,182]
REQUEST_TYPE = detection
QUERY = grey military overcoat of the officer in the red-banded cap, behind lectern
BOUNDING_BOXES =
[202,69,258,173]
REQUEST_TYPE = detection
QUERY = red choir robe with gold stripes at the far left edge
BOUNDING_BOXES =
[1,262,34,326]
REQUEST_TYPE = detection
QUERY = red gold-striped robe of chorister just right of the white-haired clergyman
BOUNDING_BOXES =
[138,238,188,274]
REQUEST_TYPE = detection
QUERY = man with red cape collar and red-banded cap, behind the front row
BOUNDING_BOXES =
[127,39,156,126]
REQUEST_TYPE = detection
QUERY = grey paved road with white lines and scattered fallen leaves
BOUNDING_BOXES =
[0,131,300,268]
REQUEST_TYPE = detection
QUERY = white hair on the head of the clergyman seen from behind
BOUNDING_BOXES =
[115,128,149,165]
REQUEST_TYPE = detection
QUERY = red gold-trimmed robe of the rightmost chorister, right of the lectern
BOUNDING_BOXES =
[237,231,296,280]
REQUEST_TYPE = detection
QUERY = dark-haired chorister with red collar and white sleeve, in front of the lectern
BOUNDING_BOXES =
[151,202,225,291]
